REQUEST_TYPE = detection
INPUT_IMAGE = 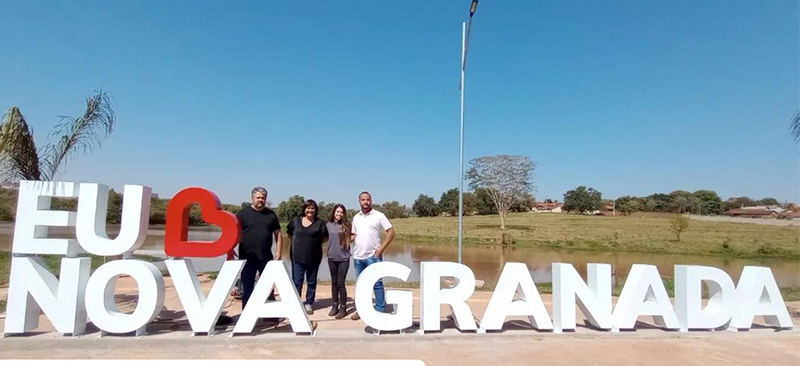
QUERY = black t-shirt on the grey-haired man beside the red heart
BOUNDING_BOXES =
[236,206,281,260]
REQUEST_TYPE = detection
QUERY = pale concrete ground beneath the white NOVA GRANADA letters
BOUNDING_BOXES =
[0,278,800,365]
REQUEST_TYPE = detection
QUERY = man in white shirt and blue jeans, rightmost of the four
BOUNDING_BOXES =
[350,191,394,320]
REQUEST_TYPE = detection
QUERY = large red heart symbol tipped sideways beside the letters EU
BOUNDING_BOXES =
[164,187,242,257]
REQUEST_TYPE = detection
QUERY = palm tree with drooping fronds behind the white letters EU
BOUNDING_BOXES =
[0,91,115,182]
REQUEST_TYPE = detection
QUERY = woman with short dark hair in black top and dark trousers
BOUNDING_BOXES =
[286,200,328,314]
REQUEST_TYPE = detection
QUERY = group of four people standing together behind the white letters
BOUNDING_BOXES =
[231,187,395,320]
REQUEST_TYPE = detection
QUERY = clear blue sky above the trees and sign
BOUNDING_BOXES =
[0,0,800,207]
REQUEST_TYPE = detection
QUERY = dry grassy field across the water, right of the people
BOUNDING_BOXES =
[392,213,800,258]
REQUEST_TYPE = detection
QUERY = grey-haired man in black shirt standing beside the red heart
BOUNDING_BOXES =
[236,187,283,310]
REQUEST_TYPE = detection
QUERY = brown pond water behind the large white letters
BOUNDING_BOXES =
[0,224,800,287]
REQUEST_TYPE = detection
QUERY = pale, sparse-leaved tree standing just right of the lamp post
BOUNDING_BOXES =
[467,155,537,229]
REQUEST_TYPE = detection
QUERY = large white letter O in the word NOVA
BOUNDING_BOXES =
[86,259,164,333]
